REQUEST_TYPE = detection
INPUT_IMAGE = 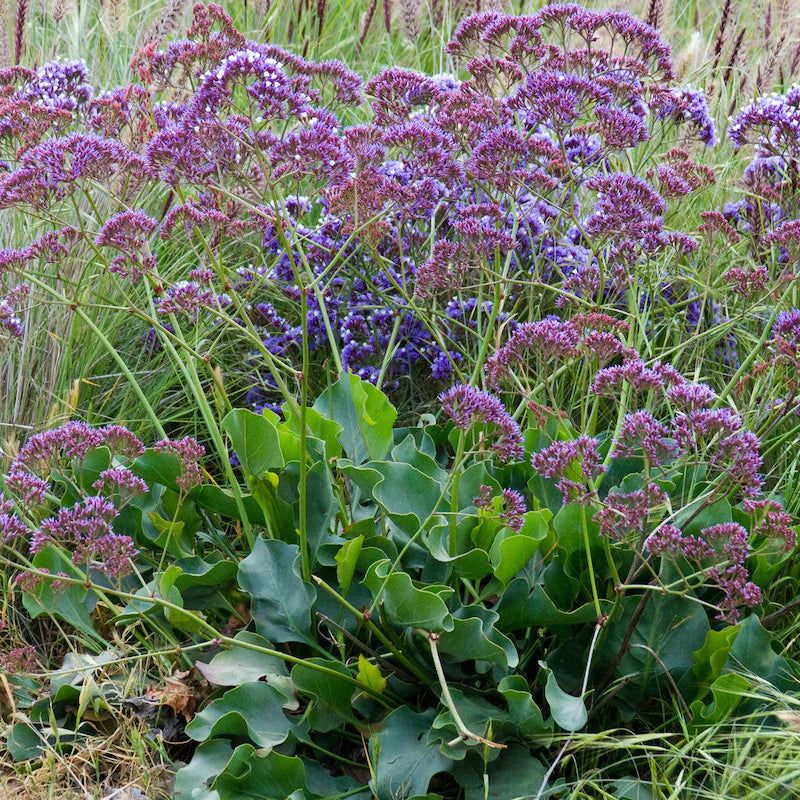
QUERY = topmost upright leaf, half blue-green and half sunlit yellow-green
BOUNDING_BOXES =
[314,373,397,464]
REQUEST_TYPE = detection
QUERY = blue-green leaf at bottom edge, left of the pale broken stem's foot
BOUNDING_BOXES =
[369,706,452,800]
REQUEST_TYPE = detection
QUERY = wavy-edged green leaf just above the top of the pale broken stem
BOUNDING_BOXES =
[363,559,453,631]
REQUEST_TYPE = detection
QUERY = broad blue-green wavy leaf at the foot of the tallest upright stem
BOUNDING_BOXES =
[239,539,315,642]
